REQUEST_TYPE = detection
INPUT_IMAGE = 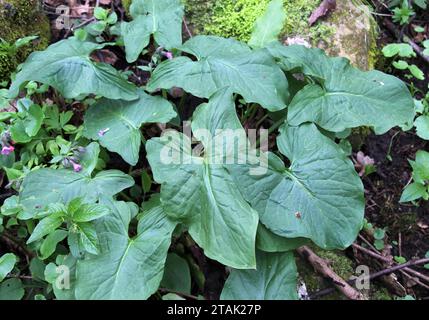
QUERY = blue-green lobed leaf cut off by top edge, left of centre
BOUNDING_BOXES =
[121,0,183,63]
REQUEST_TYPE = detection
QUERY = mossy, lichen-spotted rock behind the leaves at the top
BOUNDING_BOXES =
[183,0,378,70]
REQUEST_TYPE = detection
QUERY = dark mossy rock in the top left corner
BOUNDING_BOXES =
[0,0,51,82]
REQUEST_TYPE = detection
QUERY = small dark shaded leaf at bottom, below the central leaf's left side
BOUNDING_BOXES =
[161,253,191,294]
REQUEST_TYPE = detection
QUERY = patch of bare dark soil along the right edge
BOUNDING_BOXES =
[363,130,429,259]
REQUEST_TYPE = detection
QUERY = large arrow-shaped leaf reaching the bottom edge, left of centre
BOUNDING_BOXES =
[76,202,177,300]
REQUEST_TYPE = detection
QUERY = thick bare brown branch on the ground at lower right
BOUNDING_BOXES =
[297,246,365,300]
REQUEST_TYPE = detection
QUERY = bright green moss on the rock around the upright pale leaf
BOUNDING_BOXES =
[183,0,334,42]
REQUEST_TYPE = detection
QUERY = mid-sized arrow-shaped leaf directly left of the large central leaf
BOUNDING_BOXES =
[84,90,176,165]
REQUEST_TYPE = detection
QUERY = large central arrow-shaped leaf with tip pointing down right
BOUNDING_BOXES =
[146,90,258,269]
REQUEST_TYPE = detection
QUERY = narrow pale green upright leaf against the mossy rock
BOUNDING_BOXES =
[249,0,286,48]
